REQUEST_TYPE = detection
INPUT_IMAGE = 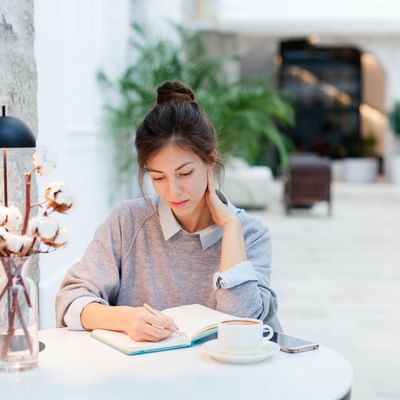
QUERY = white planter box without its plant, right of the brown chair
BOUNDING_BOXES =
[343,158,378,183]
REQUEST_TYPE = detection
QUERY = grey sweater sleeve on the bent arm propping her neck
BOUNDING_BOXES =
[216,222,278,322]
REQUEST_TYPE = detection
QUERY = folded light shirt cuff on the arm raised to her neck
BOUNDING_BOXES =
[213,261,258,289]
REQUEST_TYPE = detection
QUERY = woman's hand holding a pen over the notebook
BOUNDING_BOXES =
[124,307,178,342]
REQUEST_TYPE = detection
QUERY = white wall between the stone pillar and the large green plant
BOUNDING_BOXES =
[35,0,130,328]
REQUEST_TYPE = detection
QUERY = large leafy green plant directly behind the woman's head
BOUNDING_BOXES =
[97,24,294,199]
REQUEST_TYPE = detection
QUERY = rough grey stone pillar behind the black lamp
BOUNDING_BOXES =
[0,0,39,282]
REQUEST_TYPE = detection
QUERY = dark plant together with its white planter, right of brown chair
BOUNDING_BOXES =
[343,133,378,183]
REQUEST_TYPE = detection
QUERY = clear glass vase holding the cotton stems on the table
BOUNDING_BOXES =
[0,256,39,372]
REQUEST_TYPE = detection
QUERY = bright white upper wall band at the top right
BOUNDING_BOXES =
[212,0,400,34]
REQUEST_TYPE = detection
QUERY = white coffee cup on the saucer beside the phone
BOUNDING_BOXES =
[218,318,274,355]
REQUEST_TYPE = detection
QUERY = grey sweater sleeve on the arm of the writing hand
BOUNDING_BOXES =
[56,209,122,327]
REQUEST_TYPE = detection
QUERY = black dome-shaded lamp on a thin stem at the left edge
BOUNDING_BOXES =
[0,105,36,207]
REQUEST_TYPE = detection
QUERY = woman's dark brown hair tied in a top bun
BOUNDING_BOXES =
[135,81,222,194]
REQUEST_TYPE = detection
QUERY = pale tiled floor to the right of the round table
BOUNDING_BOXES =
[251,183,400,400]
